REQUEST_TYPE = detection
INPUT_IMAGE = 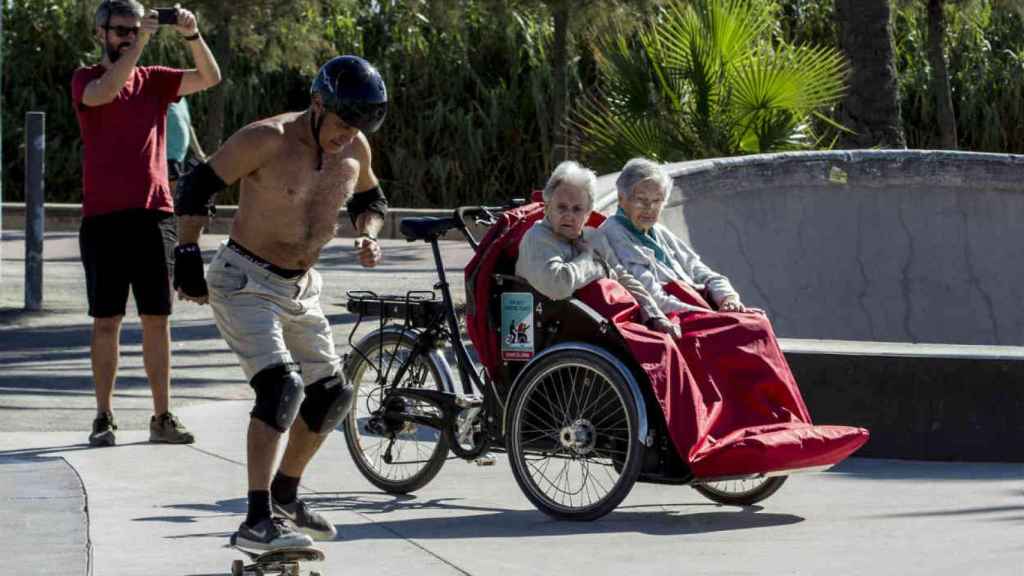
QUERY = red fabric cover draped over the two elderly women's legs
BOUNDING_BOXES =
[575,280,868,478]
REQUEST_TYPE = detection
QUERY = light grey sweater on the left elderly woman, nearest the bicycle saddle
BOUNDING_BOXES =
[515,219,665,320]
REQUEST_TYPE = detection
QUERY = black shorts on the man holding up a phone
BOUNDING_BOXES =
[78,210,178,318]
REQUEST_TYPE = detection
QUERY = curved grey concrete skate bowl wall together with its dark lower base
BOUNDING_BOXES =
[600,151,1024,461]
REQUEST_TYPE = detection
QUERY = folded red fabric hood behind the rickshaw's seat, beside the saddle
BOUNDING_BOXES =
[465,201,604,377]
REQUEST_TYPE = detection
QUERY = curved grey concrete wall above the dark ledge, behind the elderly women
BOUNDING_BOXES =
[600,151,1024,345]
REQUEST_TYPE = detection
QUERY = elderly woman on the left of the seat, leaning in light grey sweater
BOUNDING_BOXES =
[515,161,679,337]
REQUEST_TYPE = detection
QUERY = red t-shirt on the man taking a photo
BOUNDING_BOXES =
[71,65,184,216]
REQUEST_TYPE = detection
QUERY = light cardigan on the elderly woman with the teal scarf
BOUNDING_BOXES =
[600,217,739,314]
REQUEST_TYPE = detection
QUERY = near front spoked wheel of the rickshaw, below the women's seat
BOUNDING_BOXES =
[505,348,644,521]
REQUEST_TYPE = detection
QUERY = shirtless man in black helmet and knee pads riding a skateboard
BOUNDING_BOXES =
[174,56,387,550]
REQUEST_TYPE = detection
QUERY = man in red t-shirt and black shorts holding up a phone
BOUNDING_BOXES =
[72,0,220,446]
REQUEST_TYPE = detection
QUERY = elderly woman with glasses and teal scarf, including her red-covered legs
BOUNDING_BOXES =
[600,158,809,423]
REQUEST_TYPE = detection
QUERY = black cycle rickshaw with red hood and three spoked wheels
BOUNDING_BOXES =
[343,202,867,520]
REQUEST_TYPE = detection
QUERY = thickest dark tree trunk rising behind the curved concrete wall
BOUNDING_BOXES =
[835,0,906,149]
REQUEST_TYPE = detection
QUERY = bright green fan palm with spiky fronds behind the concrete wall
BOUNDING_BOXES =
[573,0,845,170]
